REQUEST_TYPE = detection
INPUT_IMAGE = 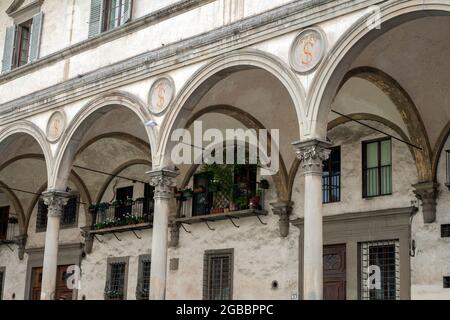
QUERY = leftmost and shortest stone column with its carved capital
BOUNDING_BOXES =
[41,190,69,300]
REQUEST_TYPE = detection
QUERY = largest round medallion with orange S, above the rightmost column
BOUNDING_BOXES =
[289,28,327,73]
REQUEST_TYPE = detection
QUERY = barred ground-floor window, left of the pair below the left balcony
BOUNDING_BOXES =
[105,258,128,300]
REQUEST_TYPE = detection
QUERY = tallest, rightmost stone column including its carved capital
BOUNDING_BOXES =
[294,140,330,300]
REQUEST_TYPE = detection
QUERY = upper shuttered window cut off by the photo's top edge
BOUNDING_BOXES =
[89,0,133,37]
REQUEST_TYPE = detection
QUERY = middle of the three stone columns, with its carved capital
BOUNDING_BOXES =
[149,170,178,300]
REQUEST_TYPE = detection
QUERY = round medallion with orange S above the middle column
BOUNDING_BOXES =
[148,77,175,114]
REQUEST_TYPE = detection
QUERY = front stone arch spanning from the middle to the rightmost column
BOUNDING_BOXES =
[153,50,306,169]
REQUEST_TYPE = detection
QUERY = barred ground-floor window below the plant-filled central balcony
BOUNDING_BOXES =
[203,249,233,300]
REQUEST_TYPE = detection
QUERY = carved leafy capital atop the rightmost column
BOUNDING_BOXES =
[293,139,331,174]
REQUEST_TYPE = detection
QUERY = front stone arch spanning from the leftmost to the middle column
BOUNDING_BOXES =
[49,91,157,189]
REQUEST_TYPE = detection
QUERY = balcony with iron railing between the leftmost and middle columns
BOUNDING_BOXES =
[90,198,154,234]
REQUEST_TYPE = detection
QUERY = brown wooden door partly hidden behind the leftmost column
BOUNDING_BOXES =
[31,266,72,300]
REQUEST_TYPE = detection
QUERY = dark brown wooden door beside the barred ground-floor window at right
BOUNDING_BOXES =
[323,244,347,300]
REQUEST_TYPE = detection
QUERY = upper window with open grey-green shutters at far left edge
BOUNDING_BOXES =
[2,13,43,72]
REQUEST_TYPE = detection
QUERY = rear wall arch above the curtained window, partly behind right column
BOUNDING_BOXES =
[288,113,416,200]
